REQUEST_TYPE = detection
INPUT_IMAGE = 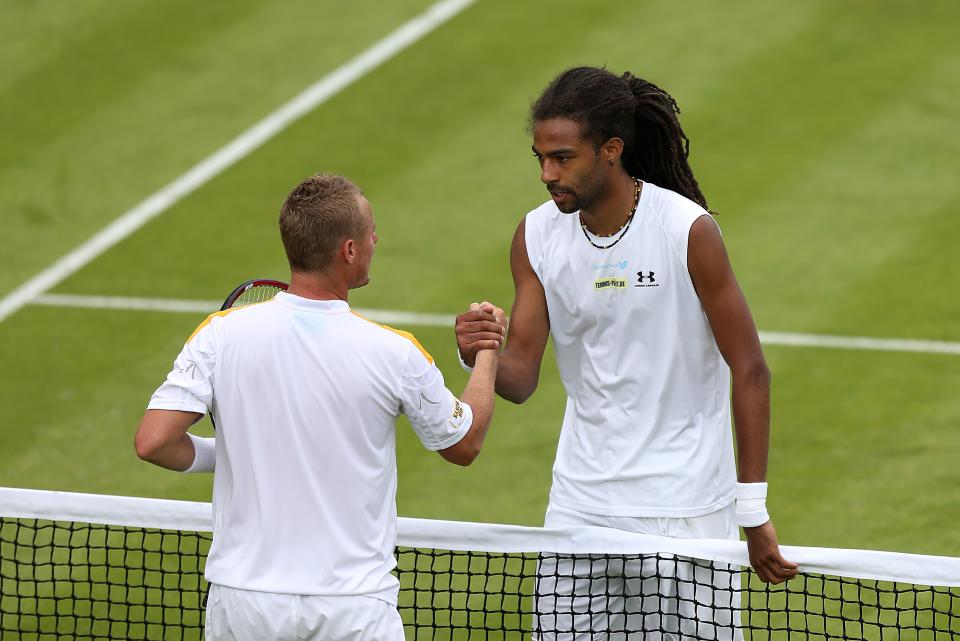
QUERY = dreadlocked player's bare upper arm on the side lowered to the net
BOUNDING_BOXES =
[687,215,763,370]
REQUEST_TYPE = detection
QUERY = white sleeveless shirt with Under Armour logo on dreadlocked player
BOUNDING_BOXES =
[525,183,736,517]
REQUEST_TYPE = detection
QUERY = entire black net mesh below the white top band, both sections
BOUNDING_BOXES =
[0,517,960,641]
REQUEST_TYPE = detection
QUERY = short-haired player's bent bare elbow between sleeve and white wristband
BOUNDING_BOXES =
[133,410,203,472]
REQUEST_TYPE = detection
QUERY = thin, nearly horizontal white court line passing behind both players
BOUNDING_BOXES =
[31,294,960,355]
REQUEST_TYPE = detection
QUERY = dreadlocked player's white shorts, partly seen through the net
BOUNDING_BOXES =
[533,504,743,641]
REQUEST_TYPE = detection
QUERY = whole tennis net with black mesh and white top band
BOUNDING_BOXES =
[0,488,960,641]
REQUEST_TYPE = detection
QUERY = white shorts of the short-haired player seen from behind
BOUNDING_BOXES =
[205,584,403,641]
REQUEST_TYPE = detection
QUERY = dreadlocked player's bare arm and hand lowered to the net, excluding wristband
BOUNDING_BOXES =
[688,216,797,583]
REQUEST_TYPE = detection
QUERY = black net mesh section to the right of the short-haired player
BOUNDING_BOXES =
[397,548,960,641]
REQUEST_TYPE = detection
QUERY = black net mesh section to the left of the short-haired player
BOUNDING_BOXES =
[0,518,210,641]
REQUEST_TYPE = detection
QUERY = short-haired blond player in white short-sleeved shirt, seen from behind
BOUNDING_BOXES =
[136,174,503,641]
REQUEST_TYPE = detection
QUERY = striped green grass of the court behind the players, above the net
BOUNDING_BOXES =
[0,0,960,572]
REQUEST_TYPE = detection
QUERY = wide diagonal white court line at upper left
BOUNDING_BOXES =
[0,0,475,322]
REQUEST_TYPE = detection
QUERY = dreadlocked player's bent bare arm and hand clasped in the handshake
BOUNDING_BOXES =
[456,221,550,403]
